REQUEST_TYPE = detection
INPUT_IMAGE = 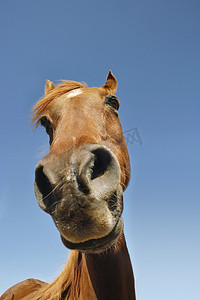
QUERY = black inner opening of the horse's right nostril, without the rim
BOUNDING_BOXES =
[91,148,112,180]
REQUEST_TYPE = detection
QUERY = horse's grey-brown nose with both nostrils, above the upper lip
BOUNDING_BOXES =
[34,144,121,214]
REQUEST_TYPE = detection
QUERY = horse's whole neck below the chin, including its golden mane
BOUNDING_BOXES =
[36,234,135,300]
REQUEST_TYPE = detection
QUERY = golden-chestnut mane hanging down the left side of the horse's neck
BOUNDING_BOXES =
[34,251,82,300]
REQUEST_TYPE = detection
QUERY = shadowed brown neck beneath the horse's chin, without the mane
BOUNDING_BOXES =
[76,234,135,300]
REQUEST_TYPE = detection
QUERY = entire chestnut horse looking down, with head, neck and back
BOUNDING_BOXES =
[1,71,135,300]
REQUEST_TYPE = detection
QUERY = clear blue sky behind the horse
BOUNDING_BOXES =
[0,0,200,300]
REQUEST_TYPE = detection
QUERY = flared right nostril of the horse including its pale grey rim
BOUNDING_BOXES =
[71,144,121,196]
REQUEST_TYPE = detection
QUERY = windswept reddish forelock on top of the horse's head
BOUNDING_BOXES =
[32,80,87,127]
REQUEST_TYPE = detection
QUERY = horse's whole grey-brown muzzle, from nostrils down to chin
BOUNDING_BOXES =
[35,144,123,252]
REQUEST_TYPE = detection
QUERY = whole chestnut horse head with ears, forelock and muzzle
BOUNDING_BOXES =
[33,71,130,253]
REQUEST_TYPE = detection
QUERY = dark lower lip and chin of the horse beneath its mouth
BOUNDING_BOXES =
[60,217,123,253]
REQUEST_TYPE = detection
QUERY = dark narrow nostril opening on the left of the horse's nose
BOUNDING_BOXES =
[35,166,55,210]
